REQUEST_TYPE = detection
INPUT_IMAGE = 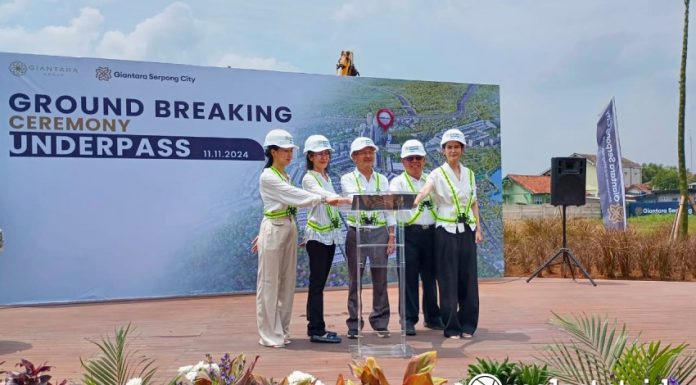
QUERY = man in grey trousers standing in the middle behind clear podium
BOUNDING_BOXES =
[341,137,395,339]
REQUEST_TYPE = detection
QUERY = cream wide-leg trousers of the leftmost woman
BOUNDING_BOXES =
[256,218,297,347]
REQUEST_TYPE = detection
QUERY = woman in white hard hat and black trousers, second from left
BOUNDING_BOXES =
[302,135,343,343]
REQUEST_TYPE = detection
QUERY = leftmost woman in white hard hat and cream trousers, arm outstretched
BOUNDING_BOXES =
[252,129,346,348]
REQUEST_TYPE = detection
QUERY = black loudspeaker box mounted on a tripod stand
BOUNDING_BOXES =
[551,158,587,206]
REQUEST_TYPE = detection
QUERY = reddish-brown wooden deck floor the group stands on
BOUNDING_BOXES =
[0,278,696,384]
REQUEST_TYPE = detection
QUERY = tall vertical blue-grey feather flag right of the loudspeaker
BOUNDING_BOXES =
[597,99,626,230]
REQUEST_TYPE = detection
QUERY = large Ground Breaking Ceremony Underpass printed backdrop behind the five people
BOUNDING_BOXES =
[0,53,503,304]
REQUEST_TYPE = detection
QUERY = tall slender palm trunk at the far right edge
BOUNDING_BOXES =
[677,0,690,240]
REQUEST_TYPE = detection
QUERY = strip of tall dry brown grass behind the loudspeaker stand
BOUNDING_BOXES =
[503,215,696,280]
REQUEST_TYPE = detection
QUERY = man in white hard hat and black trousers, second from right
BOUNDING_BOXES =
[389,139,444,336]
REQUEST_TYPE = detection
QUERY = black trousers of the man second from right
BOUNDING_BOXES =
[404,225,441,325]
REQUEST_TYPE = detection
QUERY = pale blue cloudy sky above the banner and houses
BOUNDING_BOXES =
[0,0,696,174]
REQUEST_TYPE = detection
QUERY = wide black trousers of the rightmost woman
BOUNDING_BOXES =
[435,225,479,337]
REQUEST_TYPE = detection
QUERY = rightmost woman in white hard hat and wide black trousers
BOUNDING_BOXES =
[415,128,483,339]
